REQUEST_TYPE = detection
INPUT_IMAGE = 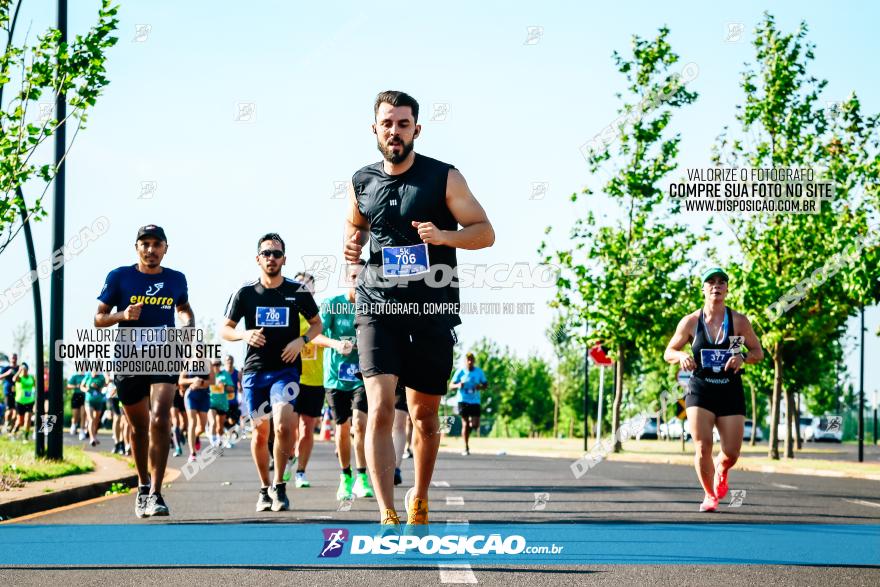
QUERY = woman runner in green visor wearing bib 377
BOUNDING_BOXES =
[663,267,764,512]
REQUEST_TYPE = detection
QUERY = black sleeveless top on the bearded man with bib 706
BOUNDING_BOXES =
[352,153,461,326]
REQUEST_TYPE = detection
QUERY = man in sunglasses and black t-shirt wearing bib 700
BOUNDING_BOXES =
[221,233,321,512]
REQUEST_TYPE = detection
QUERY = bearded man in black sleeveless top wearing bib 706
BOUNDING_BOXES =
[344,91,495,524]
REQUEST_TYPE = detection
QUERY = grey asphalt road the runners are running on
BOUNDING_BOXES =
[0,434,880,586]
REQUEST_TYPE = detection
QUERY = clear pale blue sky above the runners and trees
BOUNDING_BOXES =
[0,0,880,404]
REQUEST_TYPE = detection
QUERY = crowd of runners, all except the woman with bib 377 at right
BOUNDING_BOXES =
[44,92,495,531]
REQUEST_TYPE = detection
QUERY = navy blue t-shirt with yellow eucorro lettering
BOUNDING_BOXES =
[98,265,189,328]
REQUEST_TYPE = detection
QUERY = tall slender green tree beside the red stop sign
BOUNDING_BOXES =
[539,27,705,451]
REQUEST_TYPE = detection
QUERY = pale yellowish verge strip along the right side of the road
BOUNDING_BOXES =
[440,436,880,481]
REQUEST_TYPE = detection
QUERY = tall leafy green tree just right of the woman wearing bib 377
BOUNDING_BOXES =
[714,13,876,459]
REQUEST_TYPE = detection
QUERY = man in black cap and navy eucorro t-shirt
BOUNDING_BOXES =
[95,224,195,518]
